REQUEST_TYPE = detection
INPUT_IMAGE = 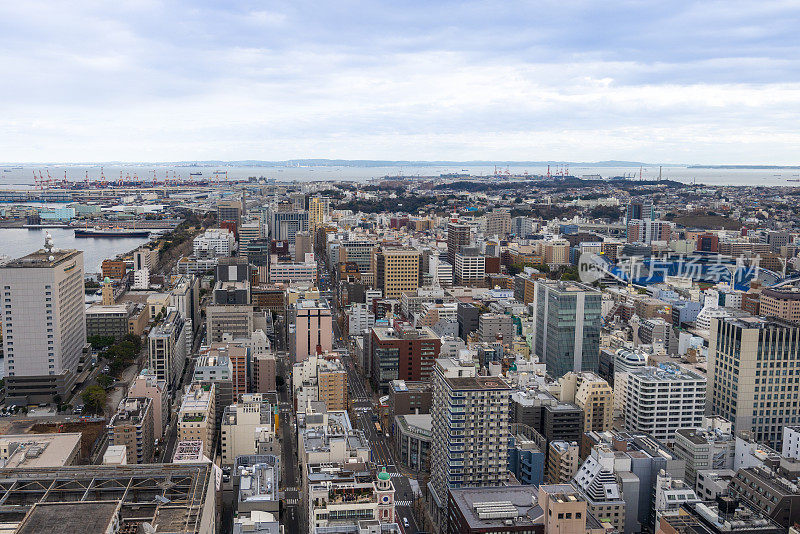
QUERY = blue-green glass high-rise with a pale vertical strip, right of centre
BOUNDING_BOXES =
[532,280,602,378]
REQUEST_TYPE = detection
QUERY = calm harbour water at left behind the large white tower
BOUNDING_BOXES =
[0,228,149,276]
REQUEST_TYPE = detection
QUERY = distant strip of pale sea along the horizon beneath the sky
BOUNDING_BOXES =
[0,164,800,189]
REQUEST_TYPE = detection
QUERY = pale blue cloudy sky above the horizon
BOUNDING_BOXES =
[0,0,800,164]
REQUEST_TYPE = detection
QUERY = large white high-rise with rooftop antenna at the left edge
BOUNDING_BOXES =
[0,245,86,404]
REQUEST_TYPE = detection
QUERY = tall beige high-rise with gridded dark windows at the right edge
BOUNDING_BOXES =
[708,317,800,450]
